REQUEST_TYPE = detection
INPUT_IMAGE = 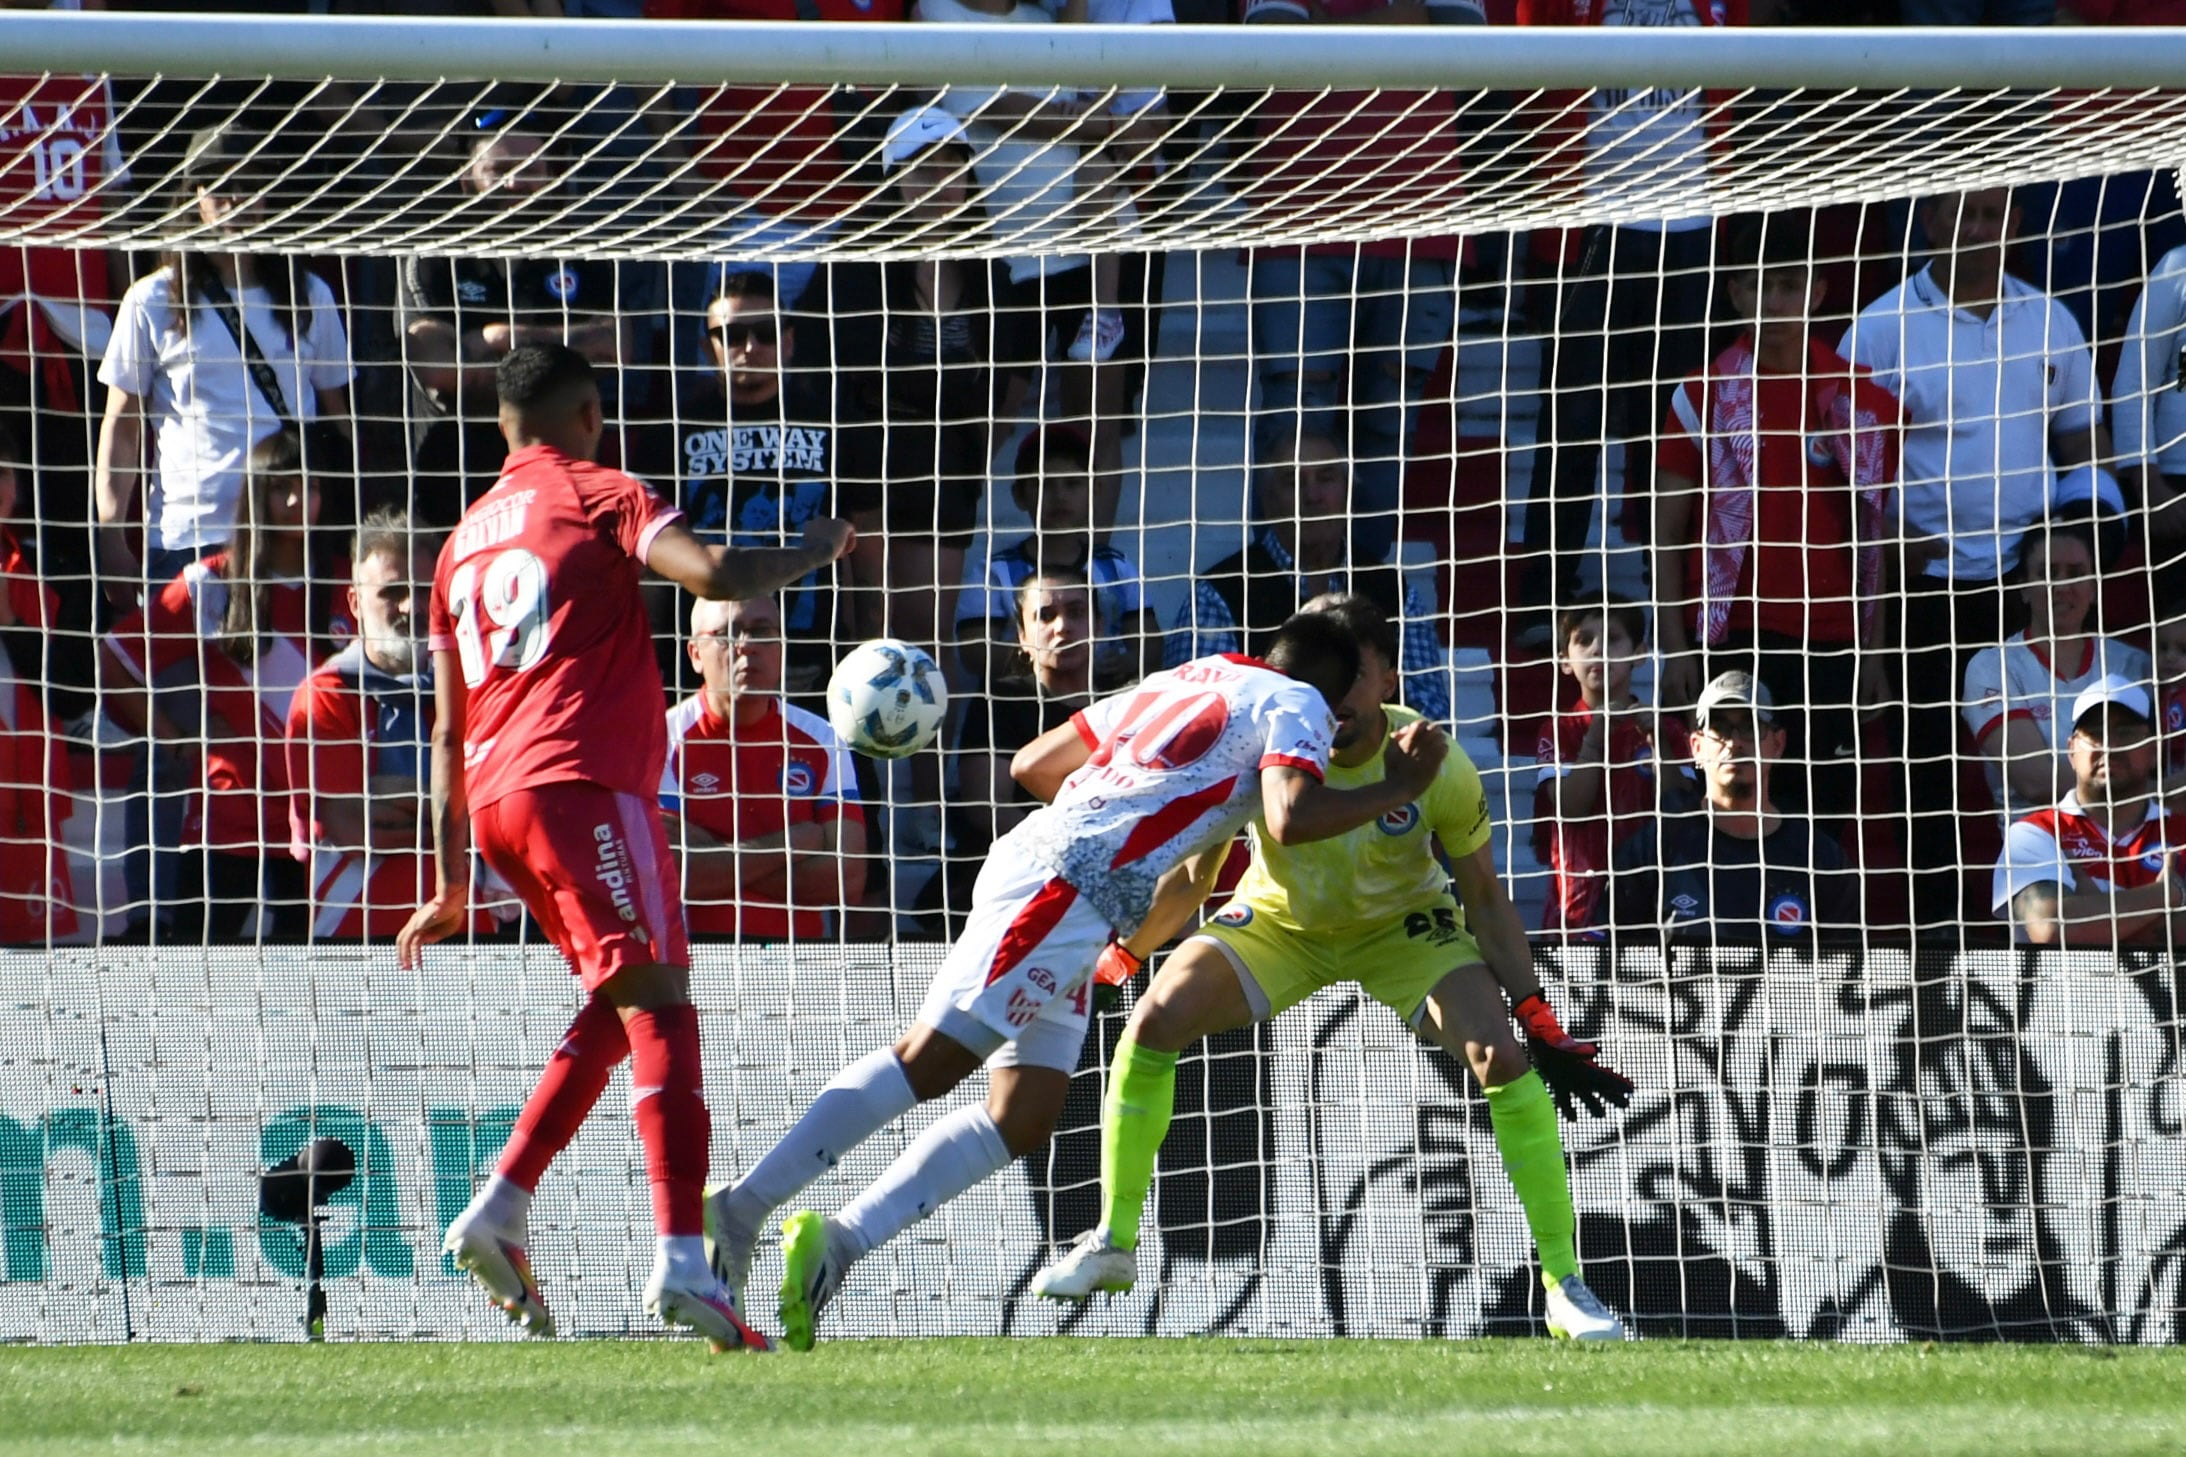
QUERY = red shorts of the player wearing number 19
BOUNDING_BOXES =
[470,780,691,992]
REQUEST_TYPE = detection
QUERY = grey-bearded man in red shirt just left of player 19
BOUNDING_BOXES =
[286,507,492,941]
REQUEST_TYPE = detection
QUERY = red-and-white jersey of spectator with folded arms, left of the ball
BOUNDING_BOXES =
[660,692,866,939]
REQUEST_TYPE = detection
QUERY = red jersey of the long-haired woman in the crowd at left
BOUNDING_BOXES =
[107,550,310,854]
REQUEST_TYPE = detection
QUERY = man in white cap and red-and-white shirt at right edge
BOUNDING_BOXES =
[1991,677,2186,948]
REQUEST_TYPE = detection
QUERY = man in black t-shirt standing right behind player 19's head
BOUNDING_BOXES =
[398,120,634,517]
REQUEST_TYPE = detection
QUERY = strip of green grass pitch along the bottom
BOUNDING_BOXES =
[0,1339,2186,1457]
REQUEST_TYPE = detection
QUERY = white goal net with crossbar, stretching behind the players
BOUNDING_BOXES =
[0,14,2186,1341]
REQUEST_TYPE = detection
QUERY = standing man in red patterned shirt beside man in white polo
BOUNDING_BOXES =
[1655,214,1904,821]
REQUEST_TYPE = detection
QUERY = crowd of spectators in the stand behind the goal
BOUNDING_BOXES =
[0,0,2186,944]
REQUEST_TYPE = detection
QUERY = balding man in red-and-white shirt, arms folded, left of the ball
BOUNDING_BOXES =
[660,596,866,941]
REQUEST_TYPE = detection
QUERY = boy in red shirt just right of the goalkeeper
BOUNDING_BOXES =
[1532,592,1694,931]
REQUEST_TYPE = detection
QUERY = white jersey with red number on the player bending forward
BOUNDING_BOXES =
[990,653,1336,937]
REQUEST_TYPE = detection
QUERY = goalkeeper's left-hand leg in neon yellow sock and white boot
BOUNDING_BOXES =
[1032,937,1257,1300]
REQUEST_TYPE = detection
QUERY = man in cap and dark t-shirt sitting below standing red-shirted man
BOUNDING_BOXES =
[1594,673,1858,941]
